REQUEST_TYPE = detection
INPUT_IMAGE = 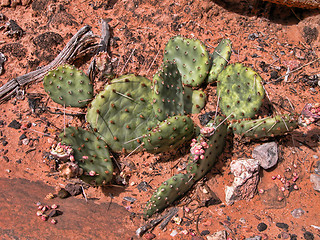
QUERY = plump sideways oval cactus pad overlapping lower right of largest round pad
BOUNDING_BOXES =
[142,116,194,153]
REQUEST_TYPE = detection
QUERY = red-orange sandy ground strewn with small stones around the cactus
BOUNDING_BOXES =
[0,0,320,239]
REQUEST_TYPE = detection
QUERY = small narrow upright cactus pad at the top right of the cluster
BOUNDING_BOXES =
[208,39,232,83]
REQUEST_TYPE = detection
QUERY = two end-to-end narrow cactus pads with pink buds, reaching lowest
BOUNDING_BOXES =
[144,117,227,218]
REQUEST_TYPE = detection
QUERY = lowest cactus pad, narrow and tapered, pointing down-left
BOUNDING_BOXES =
[144,174,194,218]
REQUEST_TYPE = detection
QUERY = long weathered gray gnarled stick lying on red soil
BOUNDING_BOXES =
[0,26,101,103]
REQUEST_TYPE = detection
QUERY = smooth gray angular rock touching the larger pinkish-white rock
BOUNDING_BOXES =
[252,142,278,169]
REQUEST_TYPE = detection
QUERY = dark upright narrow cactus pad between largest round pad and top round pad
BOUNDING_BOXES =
[152,62,184,121]
